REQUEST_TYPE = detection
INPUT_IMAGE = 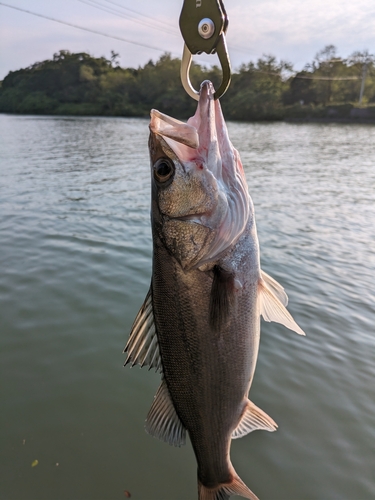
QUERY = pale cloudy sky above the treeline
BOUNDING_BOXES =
[0,0,375,80]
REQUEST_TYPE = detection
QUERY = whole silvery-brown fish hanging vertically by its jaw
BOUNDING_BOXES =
[124,81,304,500]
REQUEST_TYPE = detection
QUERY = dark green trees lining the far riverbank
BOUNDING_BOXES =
[0,45,375,121]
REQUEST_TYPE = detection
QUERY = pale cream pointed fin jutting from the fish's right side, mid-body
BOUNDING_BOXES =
[258,278,305,335]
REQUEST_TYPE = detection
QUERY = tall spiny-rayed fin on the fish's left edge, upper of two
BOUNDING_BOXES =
[124,287,162,372]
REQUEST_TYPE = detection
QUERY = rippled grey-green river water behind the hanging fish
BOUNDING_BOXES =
[0,115,375,500]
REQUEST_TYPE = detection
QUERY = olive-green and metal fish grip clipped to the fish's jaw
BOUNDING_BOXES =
[180,0,231,100]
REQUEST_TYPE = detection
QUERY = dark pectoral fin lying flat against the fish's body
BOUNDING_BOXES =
[210,266,235,330]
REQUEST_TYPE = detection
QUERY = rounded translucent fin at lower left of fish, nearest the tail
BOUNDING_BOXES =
[146,380,186,446]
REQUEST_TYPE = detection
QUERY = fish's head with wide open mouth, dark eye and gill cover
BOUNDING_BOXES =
[149,81,250,270]
